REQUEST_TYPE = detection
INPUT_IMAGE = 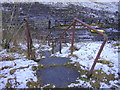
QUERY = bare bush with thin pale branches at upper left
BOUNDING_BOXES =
[2,3,25,49]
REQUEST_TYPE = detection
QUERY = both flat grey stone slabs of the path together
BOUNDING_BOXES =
[37,57,80,87]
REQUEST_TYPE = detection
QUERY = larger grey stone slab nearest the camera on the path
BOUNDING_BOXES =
[37,66,80,87]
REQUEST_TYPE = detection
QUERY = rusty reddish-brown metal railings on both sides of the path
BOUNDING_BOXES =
[25,19,107,77]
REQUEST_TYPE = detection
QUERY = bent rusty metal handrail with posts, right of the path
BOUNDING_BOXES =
[59,18,108,77]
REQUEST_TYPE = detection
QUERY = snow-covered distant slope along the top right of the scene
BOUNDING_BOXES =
[42,1,119,12]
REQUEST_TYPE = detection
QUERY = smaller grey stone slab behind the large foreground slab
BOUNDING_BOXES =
[39,57,68,65]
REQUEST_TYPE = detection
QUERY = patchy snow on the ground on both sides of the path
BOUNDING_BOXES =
[0,42,119,88]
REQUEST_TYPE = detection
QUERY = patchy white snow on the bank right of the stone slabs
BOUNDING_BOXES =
[52,42,120,88]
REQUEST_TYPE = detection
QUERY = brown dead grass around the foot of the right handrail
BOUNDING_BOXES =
[69,63,118,88]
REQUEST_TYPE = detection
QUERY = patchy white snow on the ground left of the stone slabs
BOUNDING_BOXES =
[0,43,50,89]
